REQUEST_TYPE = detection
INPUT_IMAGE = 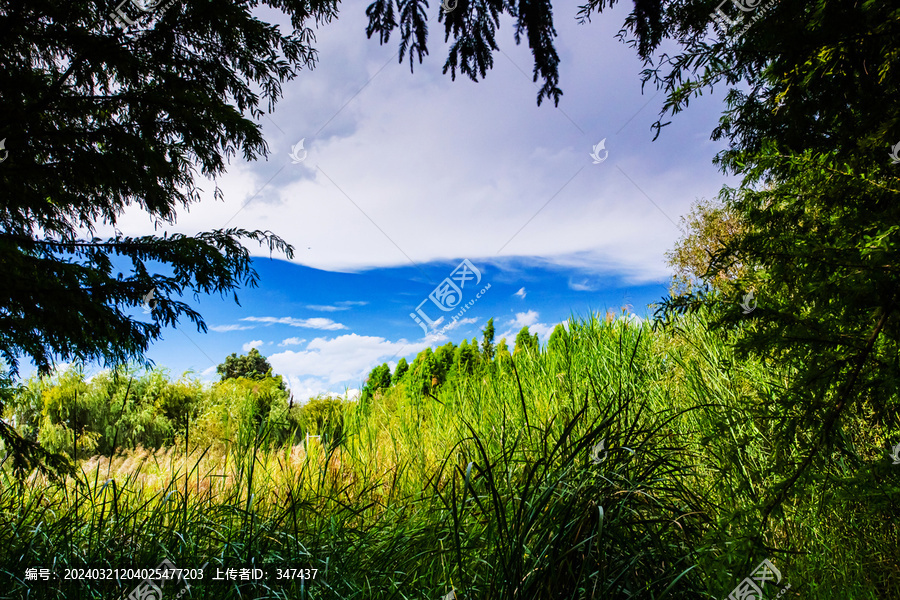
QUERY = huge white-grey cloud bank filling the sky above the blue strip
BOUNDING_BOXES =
[84,4,733,286]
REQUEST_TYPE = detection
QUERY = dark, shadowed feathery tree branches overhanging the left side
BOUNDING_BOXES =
[0,0,337,374]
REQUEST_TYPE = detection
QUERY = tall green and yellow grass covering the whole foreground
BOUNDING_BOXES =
[0,316,900,600]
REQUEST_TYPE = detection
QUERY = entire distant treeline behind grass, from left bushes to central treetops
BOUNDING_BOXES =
[2,319,566,459]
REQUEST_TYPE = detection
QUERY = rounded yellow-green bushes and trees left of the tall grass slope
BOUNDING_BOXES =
[2,349,345,459]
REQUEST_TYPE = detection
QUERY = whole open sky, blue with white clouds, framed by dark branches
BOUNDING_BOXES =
[70,3,734,400]
